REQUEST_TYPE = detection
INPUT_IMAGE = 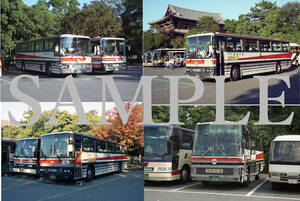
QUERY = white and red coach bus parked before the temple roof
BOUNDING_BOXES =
[185,33,291,80]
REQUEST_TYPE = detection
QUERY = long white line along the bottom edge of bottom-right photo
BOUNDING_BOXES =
[144,189,300,201]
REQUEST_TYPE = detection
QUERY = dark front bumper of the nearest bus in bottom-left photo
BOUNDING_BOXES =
[40,167,74,181]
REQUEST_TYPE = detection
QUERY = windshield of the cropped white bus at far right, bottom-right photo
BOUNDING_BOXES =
[270,141,300,163]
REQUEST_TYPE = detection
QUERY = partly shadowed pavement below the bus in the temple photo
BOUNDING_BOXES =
[144,67,300,104]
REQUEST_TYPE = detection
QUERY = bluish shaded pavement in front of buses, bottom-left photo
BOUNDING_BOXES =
[2,170,144,201]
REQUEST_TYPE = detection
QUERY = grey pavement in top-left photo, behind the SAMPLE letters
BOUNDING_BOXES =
[1,66,143,102]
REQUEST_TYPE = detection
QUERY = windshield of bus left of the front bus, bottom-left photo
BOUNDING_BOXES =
[15,139,38,158]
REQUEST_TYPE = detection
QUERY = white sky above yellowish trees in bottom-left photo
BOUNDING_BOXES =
[1,102,115,121]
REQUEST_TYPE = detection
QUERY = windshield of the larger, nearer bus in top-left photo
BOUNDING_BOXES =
[60,37,90,56]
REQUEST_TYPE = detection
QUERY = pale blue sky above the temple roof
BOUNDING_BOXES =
[143,0,299,30]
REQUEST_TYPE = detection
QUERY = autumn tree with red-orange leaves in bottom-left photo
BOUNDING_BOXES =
[92,103,144,155]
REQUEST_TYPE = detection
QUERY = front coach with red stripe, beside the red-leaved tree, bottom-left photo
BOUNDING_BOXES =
[40,132,127,180]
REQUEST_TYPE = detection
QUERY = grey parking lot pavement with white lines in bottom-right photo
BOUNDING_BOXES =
[144,175,300,201]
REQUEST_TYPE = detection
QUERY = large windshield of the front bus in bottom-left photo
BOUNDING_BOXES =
[40,133,70,158]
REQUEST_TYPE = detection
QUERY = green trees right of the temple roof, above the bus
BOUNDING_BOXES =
[224,0,300,43]
